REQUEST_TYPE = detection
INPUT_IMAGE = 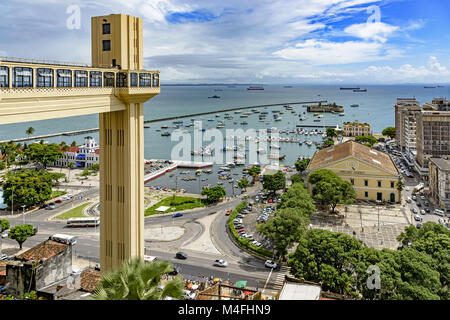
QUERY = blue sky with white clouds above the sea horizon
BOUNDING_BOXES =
[0,0,450,84]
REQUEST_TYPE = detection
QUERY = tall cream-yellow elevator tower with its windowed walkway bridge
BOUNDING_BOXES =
[0,14,160,272]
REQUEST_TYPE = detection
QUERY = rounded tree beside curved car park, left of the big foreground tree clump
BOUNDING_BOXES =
[256,208,309,259]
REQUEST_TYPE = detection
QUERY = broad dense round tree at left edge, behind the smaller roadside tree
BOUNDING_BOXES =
[3,169,54,207]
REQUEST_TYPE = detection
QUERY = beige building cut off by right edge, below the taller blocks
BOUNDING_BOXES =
[428,158,450,212]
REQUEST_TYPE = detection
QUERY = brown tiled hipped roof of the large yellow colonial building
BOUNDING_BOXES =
[308,140,398,174]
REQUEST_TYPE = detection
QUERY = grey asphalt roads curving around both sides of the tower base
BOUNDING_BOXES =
[3,188,286,290]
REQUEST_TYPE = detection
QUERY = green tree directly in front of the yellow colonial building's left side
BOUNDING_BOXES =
[308,169,356,213]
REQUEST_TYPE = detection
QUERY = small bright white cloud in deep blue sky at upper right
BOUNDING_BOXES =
[344,22,399,43]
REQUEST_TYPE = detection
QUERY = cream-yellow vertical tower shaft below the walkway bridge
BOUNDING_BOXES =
[99,103,144,272]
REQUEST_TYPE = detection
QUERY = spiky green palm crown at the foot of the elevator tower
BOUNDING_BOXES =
[92,258,184,300]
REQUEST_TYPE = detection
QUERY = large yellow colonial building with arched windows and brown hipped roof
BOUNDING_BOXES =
[307,140,401,202]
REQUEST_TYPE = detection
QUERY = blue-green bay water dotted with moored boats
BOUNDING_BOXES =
[0,85,449,194]
